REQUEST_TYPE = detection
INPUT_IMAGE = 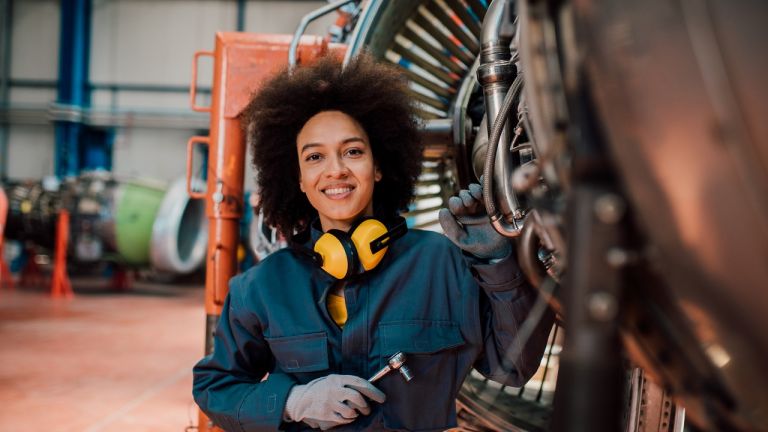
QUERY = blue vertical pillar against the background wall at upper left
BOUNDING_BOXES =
[55,0,114,177]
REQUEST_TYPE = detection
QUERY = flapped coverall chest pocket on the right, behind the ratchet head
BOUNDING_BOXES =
[376,321,464,431]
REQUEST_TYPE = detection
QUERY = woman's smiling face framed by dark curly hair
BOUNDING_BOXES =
[296,111,381,231]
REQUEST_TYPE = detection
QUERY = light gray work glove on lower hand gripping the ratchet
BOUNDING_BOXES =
[284,375,387,430]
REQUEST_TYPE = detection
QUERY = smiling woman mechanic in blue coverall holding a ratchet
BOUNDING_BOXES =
[194,56,552,431]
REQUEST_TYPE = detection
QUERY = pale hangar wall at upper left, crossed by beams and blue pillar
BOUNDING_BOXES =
[7,0,335,182]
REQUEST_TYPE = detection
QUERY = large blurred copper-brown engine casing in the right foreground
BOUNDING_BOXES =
[518,0,768,430]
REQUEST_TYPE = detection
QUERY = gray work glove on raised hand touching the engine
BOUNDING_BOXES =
[438,183,512,260]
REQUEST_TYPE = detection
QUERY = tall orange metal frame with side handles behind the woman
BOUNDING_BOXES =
[187,33,346,432]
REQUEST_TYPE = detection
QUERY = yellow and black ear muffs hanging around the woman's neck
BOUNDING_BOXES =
[310,217,408,279]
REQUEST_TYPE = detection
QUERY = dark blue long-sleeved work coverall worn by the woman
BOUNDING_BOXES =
[194,226,553,432]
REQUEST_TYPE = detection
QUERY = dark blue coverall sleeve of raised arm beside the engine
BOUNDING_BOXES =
[464,252,554,387]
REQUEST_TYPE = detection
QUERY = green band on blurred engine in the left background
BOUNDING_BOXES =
[115,181,166,265]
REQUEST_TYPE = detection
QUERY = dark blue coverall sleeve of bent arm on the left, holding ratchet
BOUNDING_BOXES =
[193,275,296,432]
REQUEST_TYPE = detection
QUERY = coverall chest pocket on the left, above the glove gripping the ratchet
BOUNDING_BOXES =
[267,332,329,383]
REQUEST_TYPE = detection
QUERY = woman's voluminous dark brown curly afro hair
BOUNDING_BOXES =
[242,54,422,238]
